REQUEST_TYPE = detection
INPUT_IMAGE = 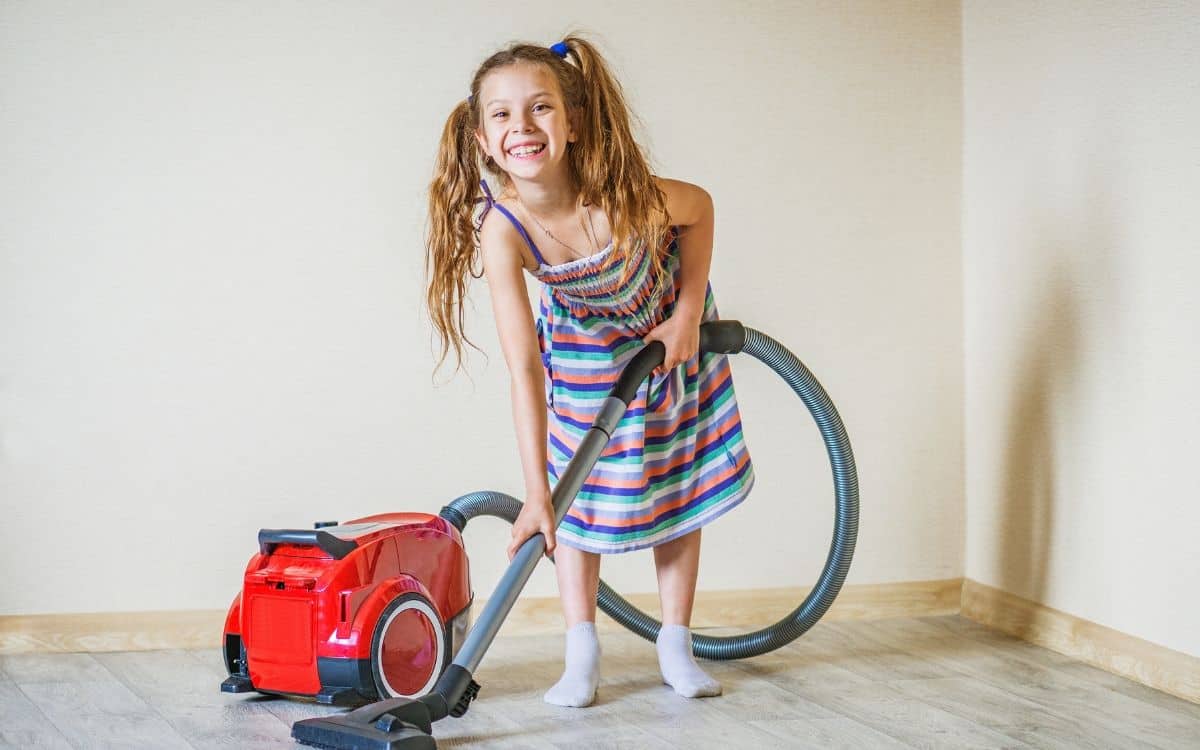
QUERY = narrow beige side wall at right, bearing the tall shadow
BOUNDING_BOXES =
[962,0,1200,655]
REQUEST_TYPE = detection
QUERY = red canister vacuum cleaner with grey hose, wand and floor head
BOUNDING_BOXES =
[221,320,858,750]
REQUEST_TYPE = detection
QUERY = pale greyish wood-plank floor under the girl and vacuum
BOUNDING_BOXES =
[0,617,1200,750]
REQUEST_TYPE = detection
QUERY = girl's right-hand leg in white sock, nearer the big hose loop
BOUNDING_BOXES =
[654,529,721,698]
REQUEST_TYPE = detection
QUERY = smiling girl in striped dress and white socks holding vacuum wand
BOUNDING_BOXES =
[426,36,754,706]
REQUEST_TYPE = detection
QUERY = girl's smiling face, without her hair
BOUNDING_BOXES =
[475,64,576,187]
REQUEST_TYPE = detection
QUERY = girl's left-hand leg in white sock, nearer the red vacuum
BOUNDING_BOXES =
[545,542,600,707]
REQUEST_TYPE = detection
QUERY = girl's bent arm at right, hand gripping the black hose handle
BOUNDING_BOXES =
[644,178,713,373]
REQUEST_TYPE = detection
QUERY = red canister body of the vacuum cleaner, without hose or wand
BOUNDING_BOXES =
[221,512,472,706]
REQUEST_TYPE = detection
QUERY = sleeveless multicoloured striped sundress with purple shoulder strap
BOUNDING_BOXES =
[480,182,754,553]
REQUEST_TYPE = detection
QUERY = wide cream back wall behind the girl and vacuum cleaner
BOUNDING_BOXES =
[0,0,964,614]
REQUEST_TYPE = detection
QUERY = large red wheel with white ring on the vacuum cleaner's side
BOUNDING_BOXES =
[371,592,449,700]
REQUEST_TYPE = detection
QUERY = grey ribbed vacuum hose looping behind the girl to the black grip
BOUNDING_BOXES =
[440,320,858,659]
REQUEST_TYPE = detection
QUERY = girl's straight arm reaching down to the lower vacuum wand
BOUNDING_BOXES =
[479,211,554,558]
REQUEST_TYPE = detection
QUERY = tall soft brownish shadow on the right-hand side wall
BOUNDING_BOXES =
[996,166,1120,604]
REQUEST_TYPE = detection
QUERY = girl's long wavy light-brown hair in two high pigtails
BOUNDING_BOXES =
[425,35,670,371]
